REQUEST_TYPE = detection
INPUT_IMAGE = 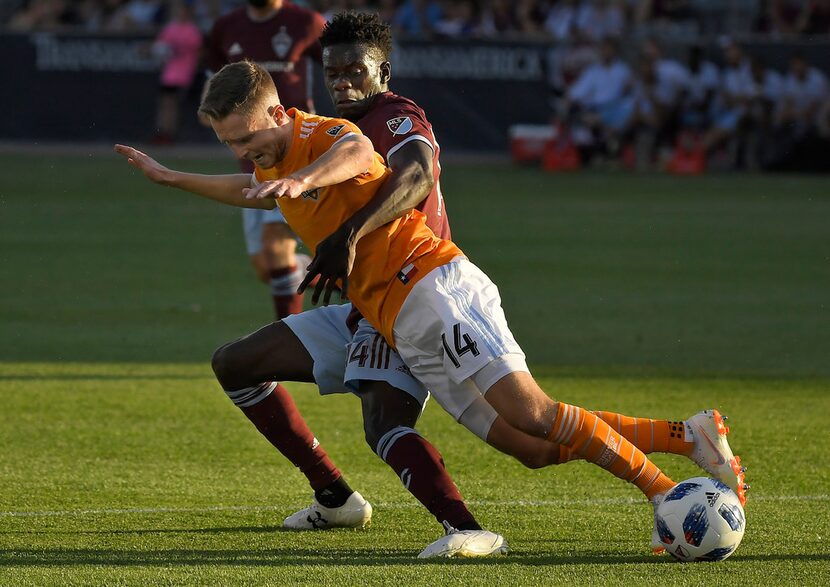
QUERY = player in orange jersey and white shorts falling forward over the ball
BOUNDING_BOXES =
[116,63,742,560]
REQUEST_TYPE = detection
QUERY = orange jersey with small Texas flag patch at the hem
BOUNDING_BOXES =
[255,108,463,346]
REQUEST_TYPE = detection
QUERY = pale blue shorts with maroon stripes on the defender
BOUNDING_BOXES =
[282,304,429,407]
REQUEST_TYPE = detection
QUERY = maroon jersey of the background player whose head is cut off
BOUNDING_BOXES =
[206,2,326,112]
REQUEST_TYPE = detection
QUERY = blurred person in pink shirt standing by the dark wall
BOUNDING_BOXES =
[153,0,202,144]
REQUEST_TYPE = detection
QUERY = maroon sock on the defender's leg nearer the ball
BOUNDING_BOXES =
[377,426,481,530]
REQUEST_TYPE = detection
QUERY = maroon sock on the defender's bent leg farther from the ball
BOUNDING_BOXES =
[239,384,341,491]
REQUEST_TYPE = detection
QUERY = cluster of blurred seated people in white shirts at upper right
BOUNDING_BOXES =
[553,37,830,173]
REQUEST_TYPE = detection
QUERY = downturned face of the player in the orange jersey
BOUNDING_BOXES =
[211,105,285,169]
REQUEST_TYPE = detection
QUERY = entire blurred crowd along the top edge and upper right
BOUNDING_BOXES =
[0,0,830,172]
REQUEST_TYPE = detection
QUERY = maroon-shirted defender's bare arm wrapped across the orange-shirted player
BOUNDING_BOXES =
[298,141,434,304]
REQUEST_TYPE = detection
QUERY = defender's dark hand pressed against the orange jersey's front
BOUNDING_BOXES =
[297,227,355,305]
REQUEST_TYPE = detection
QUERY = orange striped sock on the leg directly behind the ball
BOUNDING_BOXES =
[548,402,675,499]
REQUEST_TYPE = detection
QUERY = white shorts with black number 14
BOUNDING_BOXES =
[392,258,528,438]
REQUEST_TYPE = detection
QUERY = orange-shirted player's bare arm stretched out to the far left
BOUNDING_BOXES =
[115,145,276,209]
